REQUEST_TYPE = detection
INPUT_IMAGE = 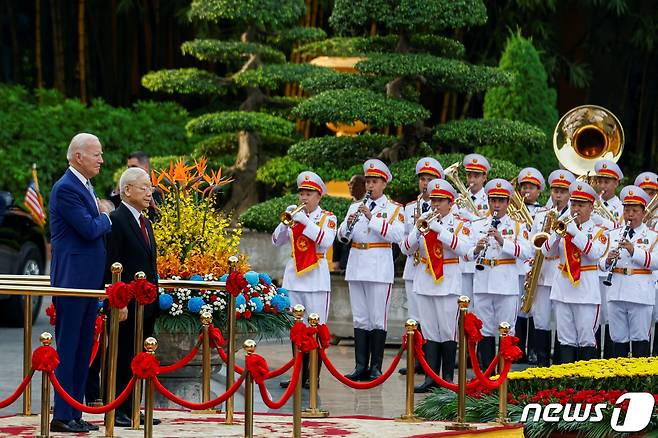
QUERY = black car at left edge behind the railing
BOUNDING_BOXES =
[0,191,47,327]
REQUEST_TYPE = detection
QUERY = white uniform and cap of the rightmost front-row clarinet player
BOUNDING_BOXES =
[599,186,658,343]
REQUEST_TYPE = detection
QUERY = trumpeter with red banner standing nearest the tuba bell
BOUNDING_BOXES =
[542,181,608,363]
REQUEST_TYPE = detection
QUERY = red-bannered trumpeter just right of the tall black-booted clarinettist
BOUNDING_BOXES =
[403,179,471,393]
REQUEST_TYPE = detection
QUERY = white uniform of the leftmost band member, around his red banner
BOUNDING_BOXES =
[272,172,337,324]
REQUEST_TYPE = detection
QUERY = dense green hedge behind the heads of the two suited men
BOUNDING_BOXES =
[0,85,198,199]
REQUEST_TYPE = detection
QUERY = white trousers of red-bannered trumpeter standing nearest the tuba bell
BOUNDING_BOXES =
[553,301,600,347]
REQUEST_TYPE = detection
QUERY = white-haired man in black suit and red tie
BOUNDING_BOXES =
[105,167,159,427]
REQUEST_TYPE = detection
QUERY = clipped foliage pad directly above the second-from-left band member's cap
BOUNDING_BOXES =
[288,134,397,169]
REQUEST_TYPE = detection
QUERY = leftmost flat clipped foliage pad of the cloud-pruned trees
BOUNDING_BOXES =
[142,68,226,95]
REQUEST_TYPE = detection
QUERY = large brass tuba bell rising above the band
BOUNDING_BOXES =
[553,105,624,175]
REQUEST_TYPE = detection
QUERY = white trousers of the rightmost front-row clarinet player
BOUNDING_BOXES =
[608,301,653,342]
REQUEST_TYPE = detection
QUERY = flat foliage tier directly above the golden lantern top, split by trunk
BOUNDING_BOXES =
[294,34,465,58]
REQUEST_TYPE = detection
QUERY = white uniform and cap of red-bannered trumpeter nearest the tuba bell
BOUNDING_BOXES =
[542,181,608,347]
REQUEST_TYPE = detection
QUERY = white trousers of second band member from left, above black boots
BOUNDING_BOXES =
[347,281,392,331]
